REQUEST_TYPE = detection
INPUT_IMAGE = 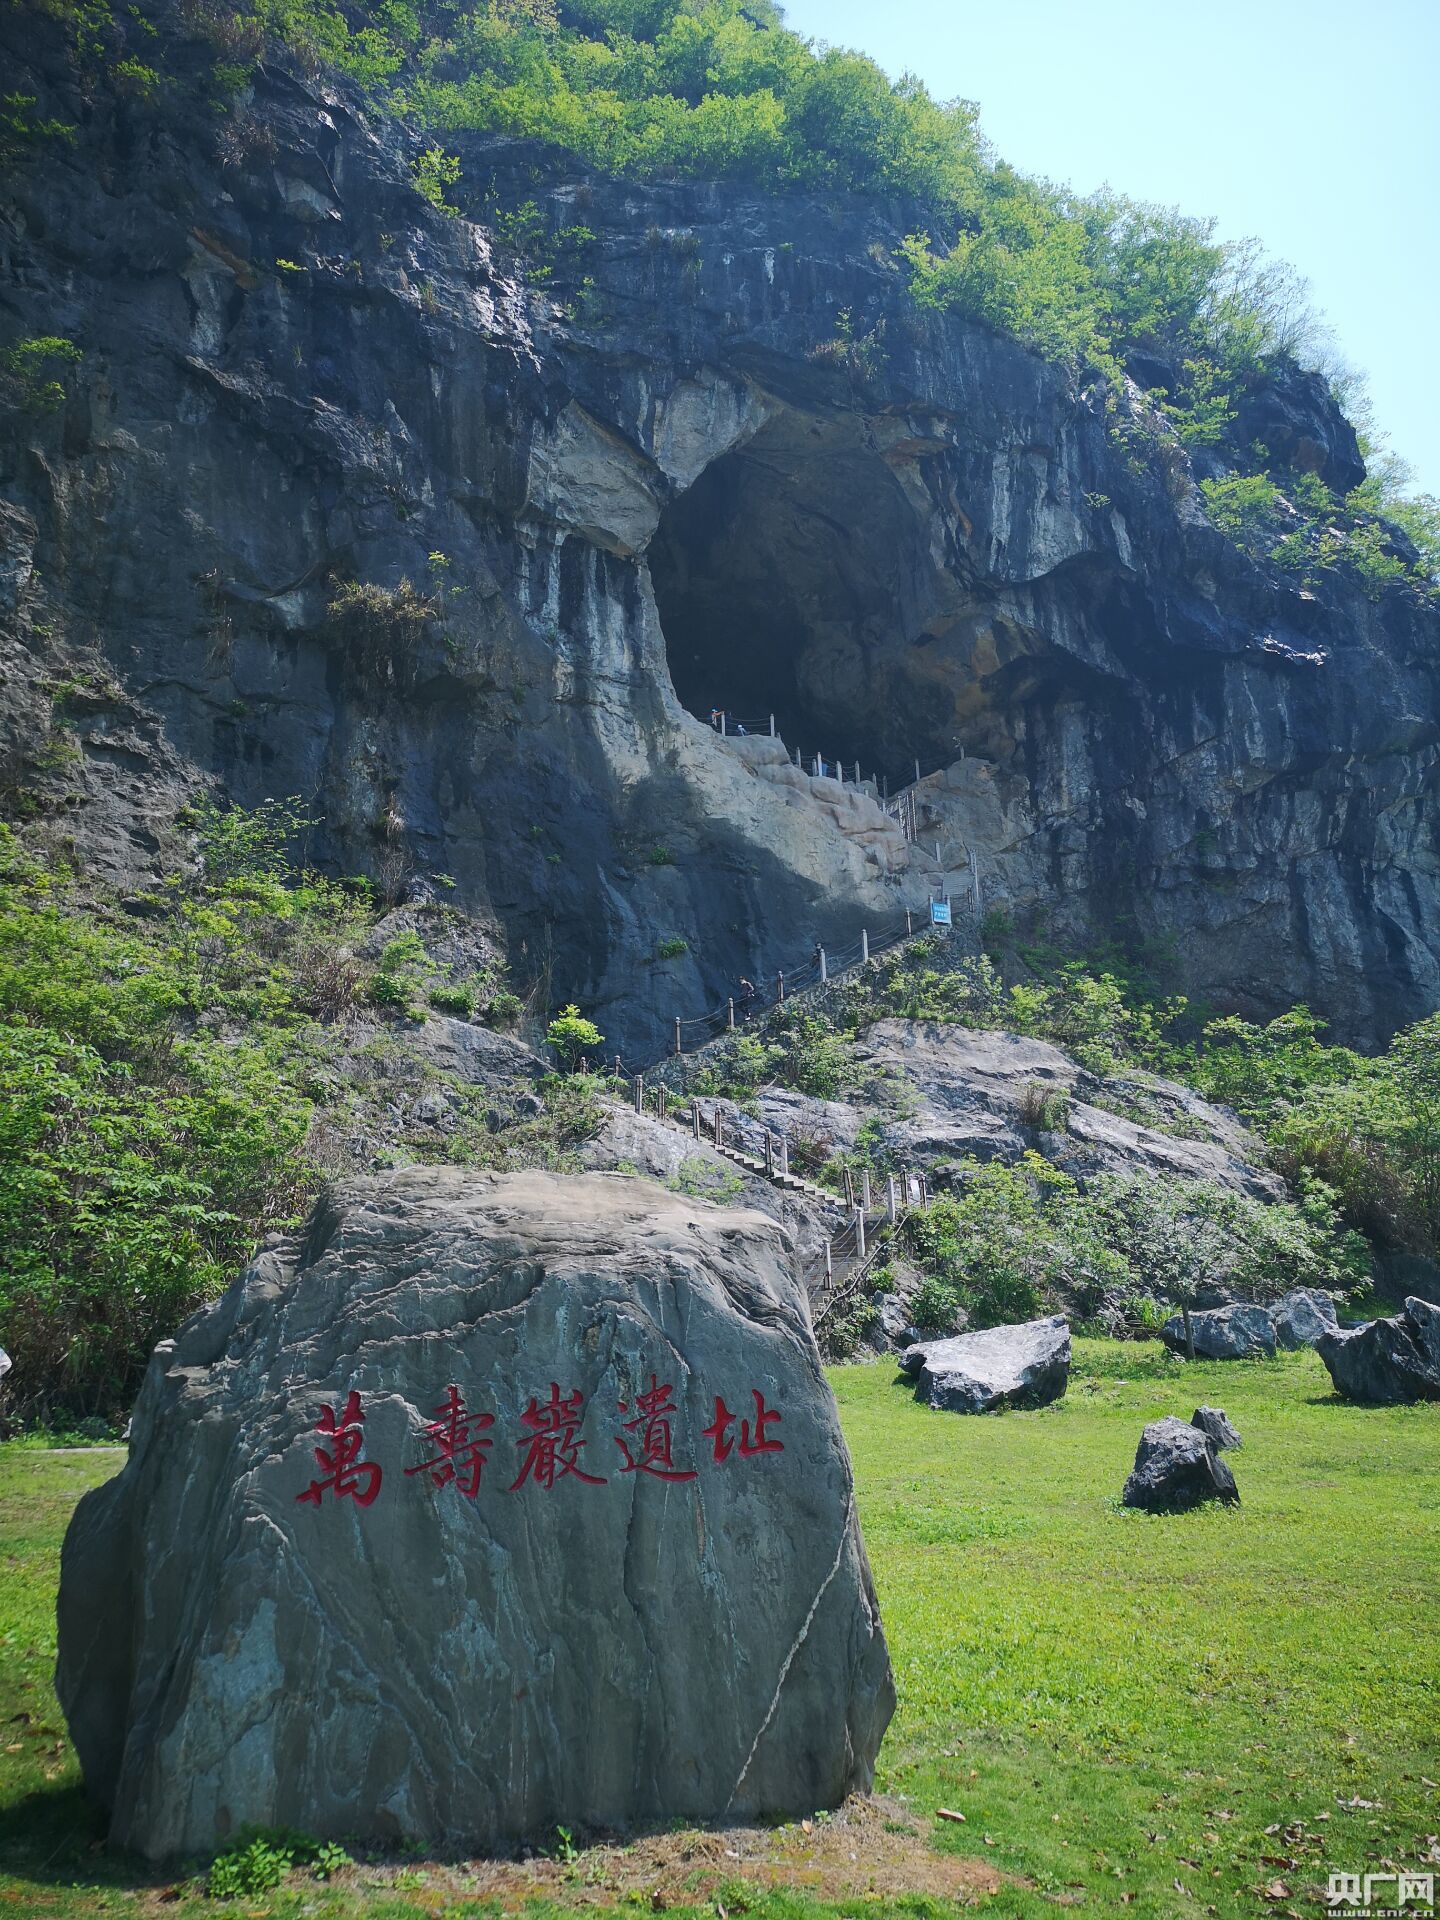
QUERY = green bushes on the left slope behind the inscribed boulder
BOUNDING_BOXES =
[0,803,599,1419]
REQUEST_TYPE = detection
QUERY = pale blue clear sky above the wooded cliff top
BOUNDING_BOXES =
[785,0,1440,493]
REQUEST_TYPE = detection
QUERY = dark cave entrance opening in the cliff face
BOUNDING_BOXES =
[649,413,941,785]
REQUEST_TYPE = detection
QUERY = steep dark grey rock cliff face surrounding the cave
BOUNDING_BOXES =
[0,12,1440,1056]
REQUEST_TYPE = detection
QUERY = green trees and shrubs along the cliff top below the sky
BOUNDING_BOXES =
[14,0,1440,576]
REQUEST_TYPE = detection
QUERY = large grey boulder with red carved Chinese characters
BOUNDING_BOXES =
[58,1167,895,1859]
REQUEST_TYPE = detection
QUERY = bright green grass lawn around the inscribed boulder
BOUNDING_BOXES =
[0,1340,1440,1920]
